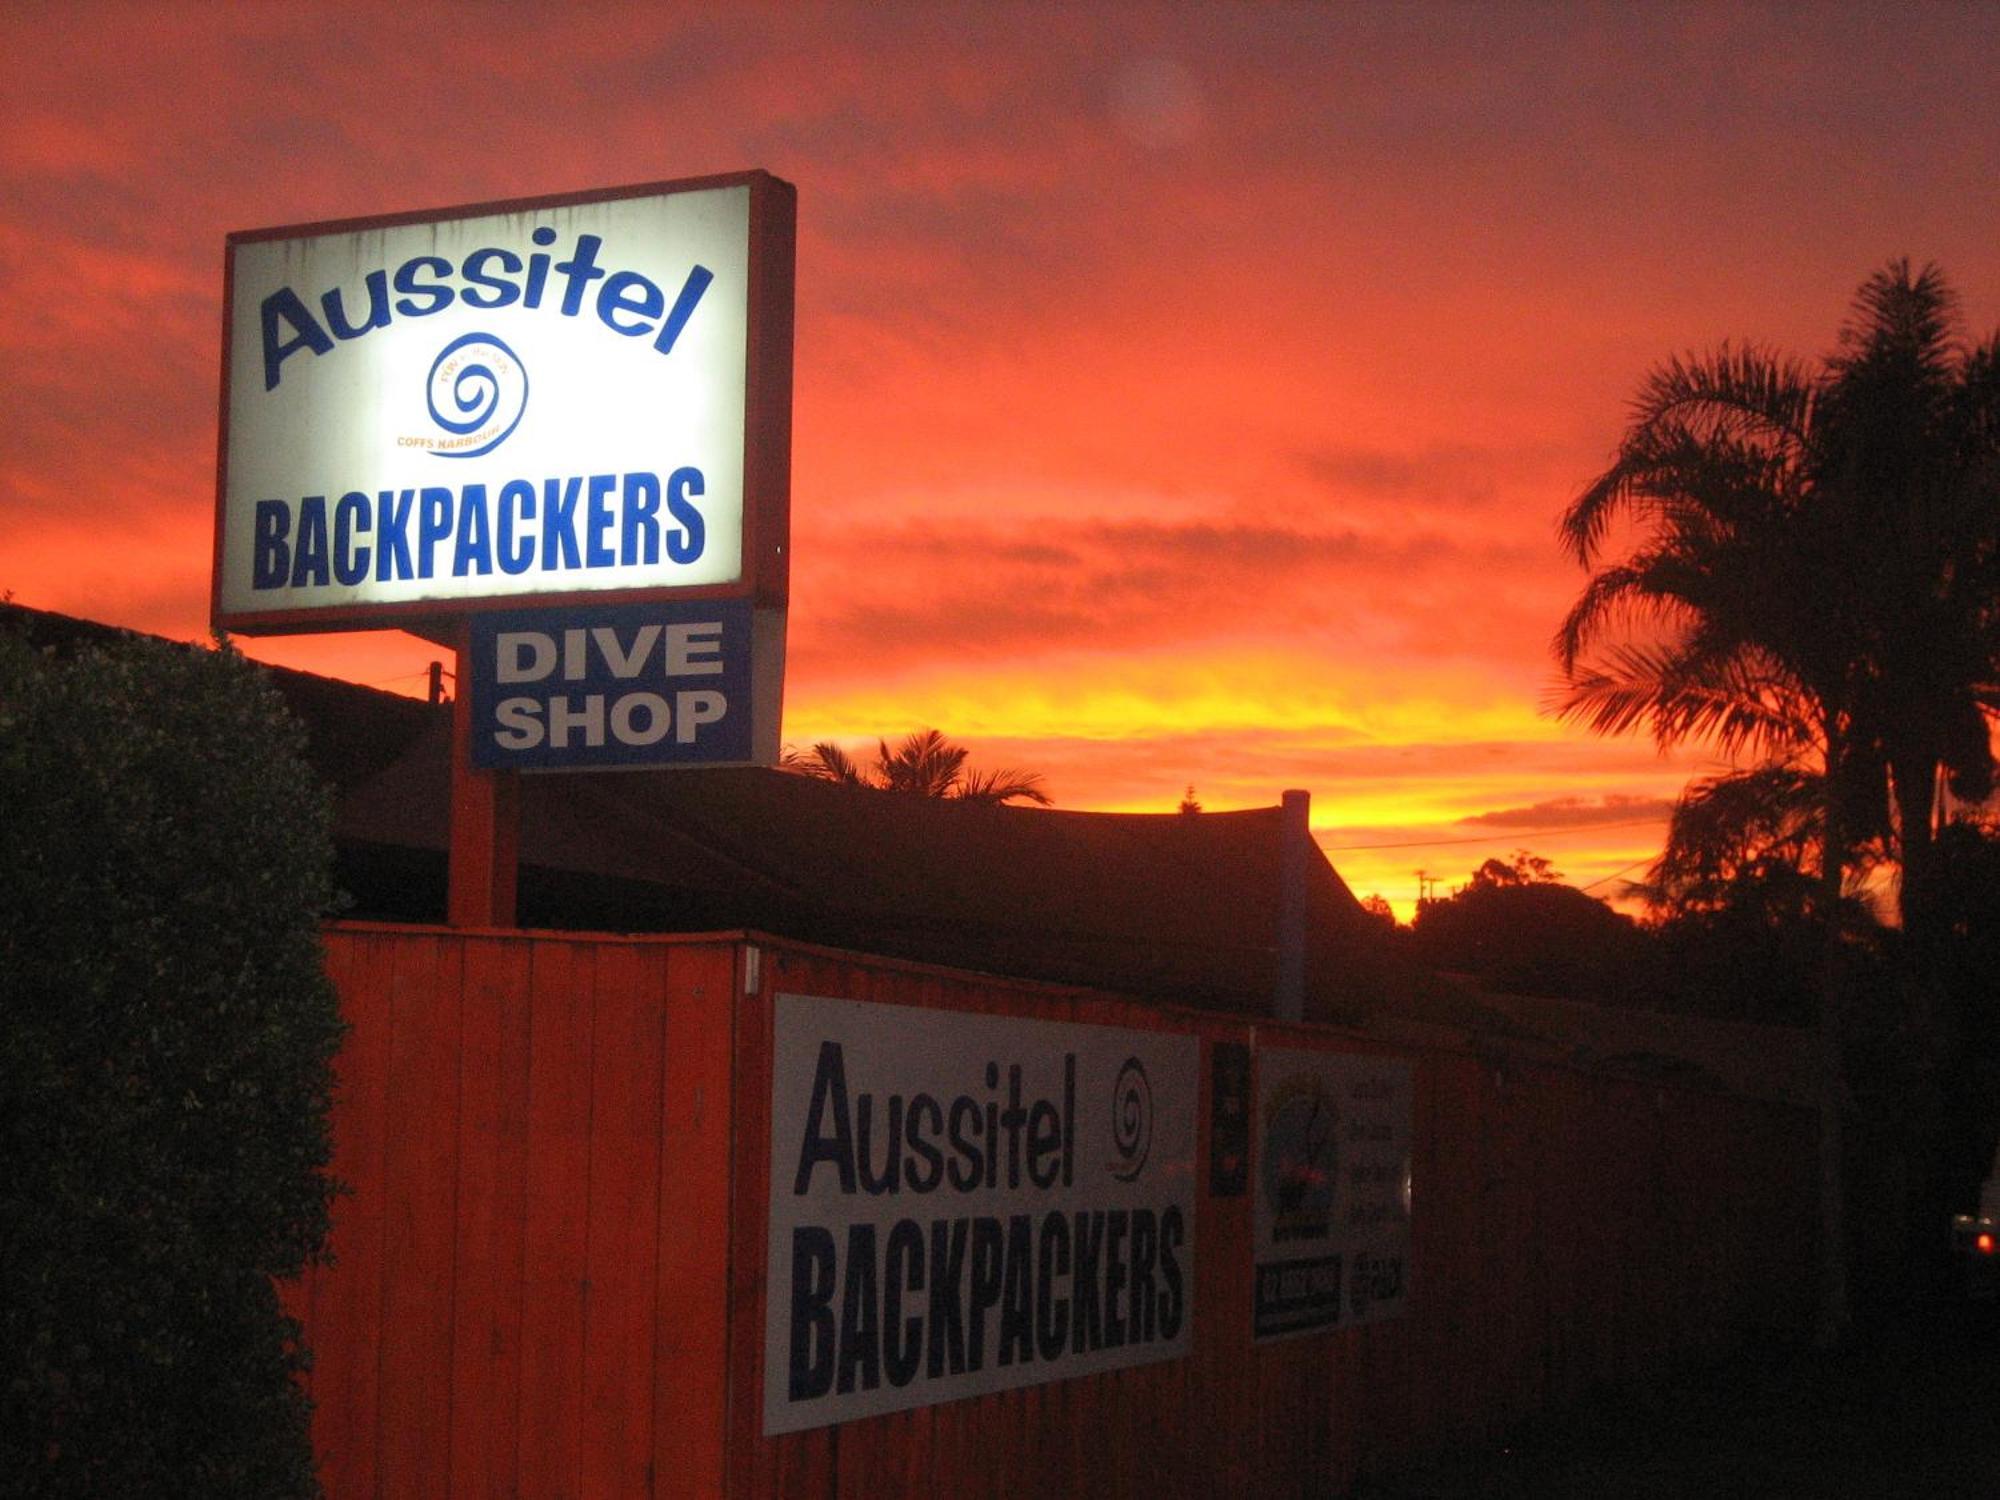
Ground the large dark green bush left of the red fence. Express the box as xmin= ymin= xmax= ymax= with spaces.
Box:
xmin=0 ymin=634 xmax=340 ymax=1500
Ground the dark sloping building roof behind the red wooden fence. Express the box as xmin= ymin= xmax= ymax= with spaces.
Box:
xmin=10 ymin=606 xmax=1392 ymax=1020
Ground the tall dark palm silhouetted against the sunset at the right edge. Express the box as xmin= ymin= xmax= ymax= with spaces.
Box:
xmin=1554 ymin=260 xmax=2000 ymax=1340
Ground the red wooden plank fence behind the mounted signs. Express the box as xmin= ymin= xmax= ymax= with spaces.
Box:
xmin=292 ymin=924 xmax=1814 ymax=1500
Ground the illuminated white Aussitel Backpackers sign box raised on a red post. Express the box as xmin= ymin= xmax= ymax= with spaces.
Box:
xmin=214 ymin=172 xmax=794 ymax=632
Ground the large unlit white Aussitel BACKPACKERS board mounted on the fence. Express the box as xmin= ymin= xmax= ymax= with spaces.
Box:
xmin=764 ymin=996 xmax=1200 ymax=1434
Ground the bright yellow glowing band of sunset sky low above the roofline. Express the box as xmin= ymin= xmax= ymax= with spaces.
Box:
xmin=786 ymin=650 xmax=1686 ymax=922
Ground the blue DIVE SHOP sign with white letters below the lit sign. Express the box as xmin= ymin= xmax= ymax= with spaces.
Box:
xmin=472 ymin=598 xmax=776 ymax=770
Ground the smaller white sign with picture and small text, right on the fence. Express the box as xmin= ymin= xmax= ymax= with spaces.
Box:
xmin=1252 ymin=1050 xmax=1412 ymax=1340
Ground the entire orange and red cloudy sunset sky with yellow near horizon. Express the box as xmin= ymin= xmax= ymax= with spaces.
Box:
xmin=0 ymin=4 xmax=2000 ymax=916
